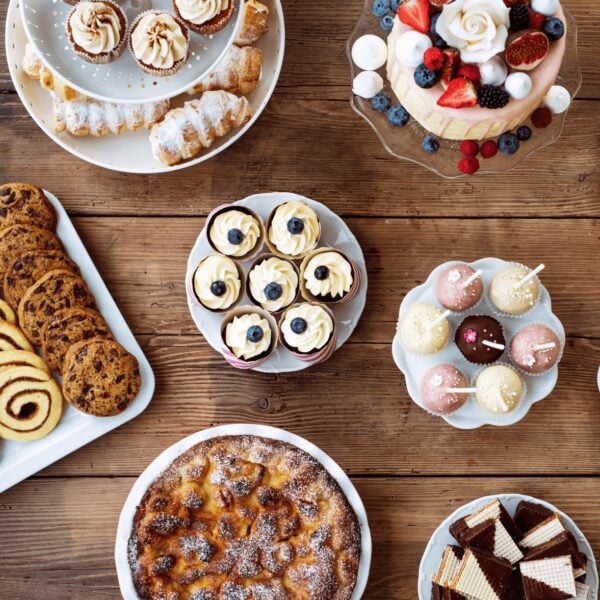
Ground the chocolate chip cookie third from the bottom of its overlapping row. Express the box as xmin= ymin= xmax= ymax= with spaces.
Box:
xmin=18 ymin=269 xmax=96 ymax=345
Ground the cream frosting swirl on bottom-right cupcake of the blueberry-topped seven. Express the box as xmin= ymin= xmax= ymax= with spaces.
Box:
xmin=281 ymin=303 xmax=334 ymax=354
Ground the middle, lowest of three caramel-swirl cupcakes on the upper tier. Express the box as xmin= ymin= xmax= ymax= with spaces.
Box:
xmin=129 ymin=10 xmax=190 ymax=77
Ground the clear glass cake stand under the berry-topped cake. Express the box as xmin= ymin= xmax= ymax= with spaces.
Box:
xmin=346 ymin=0 xmax=581 ymax=179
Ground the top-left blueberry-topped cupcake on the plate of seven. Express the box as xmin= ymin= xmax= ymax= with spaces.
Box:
xmin=207 ymin=204 xmax=265 ymax=260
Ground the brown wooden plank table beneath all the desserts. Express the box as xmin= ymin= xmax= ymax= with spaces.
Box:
xmin=0 ymin=0 xmax=600 ymax=600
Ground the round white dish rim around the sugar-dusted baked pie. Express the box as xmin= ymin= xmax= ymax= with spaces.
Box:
xmin=115 ymin=424 xmax=373 ymax=600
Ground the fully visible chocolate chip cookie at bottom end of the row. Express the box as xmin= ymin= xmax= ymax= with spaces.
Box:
xmin=63 ymin=338 xmax=141 ymax=417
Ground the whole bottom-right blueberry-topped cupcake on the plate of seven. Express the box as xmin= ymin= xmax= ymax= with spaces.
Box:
xmin=279 ymin=302 xmax=336 ymax=363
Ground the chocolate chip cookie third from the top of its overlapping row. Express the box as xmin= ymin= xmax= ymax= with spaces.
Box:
xmin=4 ymin=250 xmax=79 ymax=308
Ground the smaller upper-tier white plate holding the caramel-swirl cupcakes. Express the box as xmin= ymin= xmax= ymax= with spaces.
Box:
xmin=20 ymin=0 xmax=243 ymax=102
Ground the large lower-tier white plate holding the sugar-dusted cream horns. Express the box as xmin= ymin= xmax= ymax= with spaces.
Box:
xmin=5 ymin=0 xmax=285 ymax=174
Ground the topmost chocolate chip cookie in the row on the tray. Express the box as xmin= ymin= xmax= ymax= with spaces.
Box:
xmin=0 ymin=183 xmax=56 ymax=230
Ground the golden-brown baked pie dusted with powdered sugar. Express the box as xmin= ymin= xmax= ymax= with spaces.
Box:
xmin=129 ymin=435 xmax=360 ymax=600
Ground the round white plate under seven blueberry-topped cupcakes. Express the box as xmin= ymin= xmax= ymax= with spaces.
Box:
xmin=186 ymin=192 xmax=368 ymax=373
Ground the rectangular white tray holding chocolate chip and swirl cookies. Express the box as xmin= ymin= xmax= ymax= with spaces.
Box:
xmin=0 ymin=192 xmax=154 ymax=492
